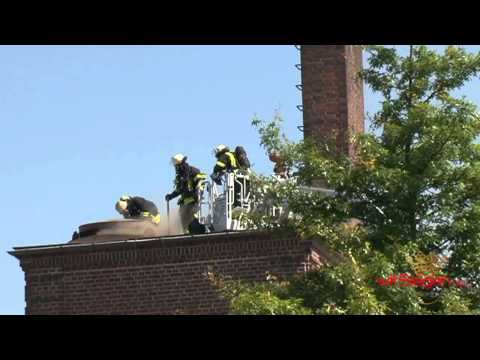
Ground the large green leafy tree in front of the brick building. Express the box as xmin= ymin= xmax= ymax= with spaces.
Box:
xmin=212 ymin=46 xmax=480 ymax=314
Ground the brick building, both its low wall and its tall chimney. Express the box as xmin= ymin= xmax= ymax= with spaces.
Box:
xmin=10 ymin=45 xmax=363 ymax=314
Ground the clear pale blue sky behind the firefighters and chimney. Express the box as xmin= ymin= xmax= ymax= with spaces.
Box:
xmin=0 ymin=45 xmax=480 ymax=314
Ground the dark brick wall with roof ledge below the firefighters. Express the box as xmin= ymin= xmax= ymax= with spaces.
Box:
xmin=11 ymin=233 xmax=329 ymax=314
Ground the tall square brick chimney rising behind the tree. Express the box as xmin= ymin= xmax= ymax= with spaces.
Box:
xmin=300 ymin=45 xmax=364 ymax=157
